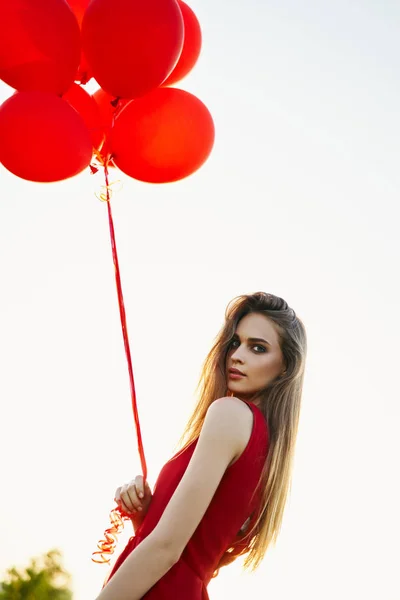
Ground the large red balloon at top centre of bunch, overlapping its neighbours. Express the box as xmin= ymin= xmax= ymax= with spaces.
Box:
xmin=82 ymin=0 xmax=183 ymax=98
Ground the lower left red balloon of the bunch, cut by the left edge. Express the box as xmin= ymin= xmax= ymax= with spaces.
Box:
xmin=0 ymin=92 xmax=92 ymax=182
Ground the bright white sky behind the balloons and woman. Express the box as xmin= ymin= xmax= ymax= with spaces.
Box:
xmin=0 ymin=0 xmax=400 ymax=600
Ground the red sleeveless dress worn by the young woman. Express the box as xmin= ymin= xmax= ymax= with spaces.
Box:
xmin=108 ymin=401 xmax=269 ymax=600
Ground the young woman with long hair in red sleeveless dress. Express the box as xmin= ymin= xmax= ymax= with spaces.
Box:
xmin=97 ymin=292 xmax=307 ymax=600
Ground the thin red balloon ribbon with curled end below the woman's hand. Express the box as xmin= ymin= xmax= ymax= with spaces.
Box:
xmin=92 ymin=160 xmax=147 ymax=563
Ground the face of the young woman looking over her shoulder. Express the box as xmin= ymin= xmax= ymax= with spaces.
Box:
xmin=226 ymin=313 xmax=284 ymax=399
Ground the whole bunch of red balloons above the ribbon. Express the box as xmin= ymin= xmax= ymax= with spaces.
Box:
xmin=0 ymin=0 xmax=214 ymax=183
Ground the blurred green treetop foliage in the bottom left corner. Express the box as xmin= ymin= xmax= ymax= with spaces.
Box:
xmin=0 ymin=549 xmax=72 ymax=600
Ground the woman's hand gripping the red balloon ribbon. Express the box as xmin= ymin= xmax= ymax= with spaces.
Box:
xmin=114 ymin=475 xmax=153 ymax=531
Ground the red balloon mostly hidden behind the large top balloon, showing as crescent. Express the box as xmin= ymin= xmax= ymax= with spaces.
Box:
xmin=163 ymin=0 xmax=202 ymax=85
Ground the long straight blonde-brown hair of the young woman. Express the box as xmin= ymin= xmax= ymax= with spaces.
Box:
xmin=173 ymin=292 xmax=307 ymax=577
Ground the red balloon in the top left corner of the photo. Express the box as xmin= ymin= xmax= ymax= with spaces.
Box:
xmin=0 ymin=0 xmax=80 ymax=94
